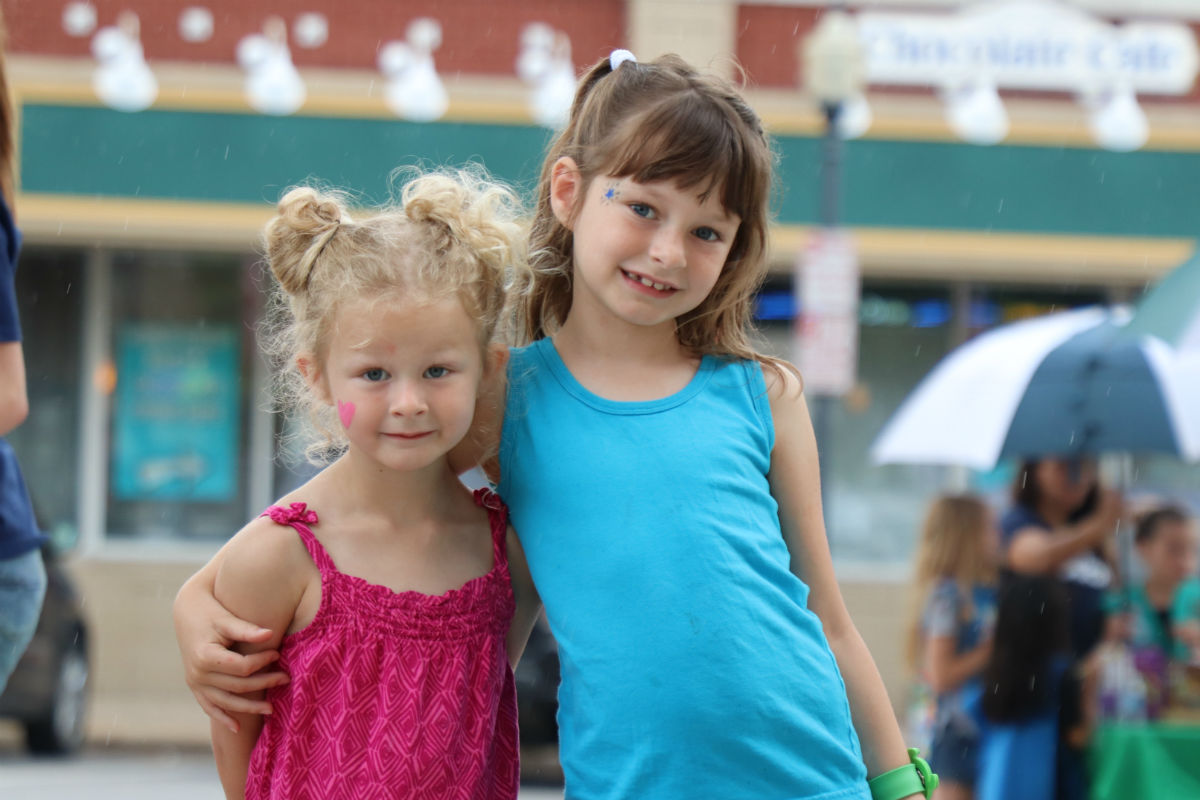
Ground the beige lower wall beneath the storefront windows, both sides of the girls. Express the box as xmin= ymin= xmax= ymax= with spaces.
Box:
xmin=70 ymin=560 xmax=906 ymax=745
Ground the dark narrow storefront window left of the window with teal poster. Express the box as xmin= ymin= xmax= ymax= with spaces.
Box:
xmin=7 ymin=247 xmax=85 ymax=548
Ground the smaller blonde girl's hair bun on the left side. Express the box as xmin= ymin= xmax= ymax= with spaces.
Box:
xmin=265 ymin=186 xmax=350 ymax=295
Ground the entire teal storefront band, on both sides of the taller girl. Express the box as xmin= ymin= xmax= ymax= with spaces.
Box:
xmin=22 ymin=104 xmax=1200 ymax=236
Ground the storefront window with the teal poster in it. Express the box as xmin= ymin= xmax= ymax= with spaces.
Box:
xmin=107 ymin=253 xmax=258 ymax=539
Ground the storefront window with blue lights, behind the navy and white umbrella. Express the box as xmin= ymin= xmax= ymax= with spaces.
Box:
xmin=757 ymin=281 xmax=1152 ymax=564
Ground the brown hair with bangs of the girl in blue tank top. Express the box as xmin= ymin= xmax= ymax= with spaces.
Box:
xmin=522 ymin=55 xmax=779 ymax=366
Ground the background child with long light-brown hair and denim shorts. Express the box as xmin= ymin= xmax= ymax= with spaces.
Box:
xmin=908 ymin=495 xmax=998 ymax=800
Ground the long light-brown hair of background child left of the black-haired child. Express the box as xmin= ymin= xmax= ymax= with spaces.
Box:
xmin=907 ymin=494 xmax=996 ymax=670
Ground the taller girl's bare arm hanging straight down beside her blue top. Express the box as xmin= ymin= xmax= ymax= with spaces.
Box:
xmin=763 ymin=368 xmax=918 ymax=796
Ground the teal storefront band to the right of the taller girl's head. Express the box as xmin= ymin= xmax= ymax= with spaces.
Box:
xmin=778 ymin=137 xmax=1200 ymax=236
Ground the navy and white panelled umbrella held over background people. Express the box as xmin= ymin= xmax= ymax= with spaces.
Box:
xmin=871 ymin=307 xmax=1200 ymax=470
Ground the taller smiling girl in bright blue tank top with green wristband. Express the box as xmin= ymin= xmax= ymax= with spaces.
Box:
xmin=176 ymin=50 xmax=936 ymax=800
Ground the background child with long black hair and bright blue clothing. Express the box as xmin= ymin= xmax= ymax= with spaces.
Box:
xmin=976 ymin=575 xmax=1092 ymax=800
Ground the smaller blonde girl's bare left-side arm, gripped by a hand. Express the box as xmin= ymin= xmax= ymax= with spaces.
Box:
xmin=211 ymin=517 xmax=316 ymax=800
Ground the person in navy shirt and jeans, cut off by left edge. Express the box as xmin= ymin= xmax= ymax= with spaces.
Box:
xmin=0 ymin=6 xmax=46 ymax=692
